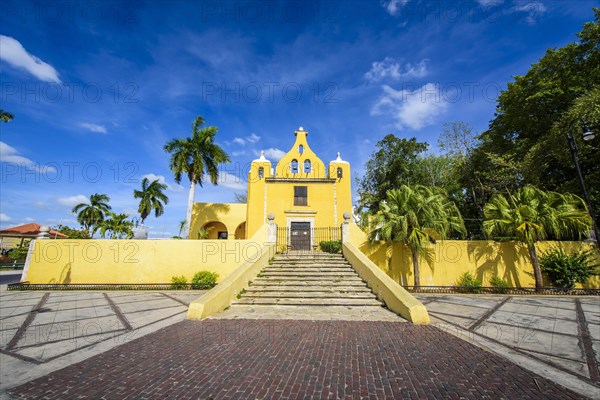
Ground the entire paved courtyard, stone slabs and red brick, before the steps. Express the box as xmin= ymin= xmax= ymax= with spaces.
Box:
xmin=0 ymin=291 xmax=600 ymax=399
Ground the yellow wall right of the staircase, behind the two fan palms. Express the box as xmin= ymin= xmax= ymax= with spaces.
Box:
xmin=350 ymin=224 xmax=600 ymax=288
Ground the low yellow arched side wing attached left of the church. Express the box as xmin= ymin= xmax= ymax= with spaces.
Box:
xmin=190 ymin=203 xmax=248 ymax=239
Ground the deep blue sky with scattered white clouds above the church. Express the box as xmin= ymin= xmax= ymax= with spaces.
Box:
xmin=0 ymin=0 xmax=600 ymax=237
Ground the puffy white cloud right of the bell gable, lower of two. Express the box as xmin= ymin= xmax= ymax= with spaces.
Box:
xmin=371 ymin=83 xmax=448 ymax=129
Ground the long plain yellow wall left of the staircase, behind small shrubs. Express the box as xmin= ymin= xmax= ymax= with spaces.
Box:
xmin=22 ymin=225 xmax=267 ymax=284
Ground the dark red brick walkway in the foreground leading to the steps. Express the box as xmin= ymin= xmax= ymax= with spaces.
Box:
xmin=9 ymin=320 xmax=583 ymax=399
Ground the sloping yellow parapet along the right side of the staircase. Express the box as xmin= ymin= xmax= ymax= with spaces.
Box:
xmin=343 ymin=242 xmax=429 ymax=325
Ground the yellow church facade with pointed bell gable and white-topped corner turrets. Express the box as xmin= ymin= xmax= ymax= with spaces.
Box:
xmin=247 ymin=130 xmax=352 ymax=238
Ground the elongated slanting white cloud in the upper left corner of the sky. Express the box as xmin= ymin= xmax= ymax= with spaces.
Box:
xmin=0 ymin=35 xmax=61 ymax=83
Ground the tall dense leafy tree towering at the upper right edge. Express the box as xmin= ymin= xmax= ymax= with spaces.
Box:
xmin=473 ymin=8 xmax=600 ymax=214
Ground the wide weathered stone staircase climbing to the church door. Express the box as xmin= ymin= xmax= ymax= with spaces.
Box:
xmin=233 ymin=253 xmax=383 ymax=310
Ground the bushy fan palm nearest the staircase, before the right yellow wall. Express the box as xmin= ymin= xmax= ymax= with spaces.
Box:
xmin=370 ymin=185 xmax=466 ymax=286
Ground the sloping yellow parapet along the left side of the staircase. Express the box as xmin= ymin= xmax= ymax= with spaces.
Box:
xmin=186 ymin=225 xmax=276 ymax=320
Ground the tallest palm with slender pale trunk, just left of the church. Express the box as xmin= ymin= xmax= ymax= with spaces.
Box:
xmin=164 ymin=116 xmax=229 ymax=239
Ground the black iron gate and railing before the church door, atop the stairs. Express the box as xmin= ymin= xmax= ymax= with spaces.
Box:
xmin=277 ymin=222 xmax=342 ymax=253
